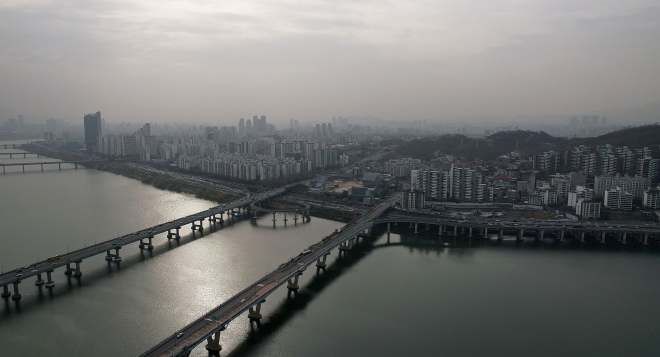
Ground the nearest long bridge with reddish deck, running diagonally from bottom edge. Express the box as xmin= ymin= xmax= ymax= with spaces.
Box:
xmin=141 ymin=200 xmax=394 ymax=357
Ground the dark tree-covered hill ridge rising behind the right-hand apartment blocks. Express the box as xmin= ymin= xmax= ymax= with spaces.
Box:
xmin=396 ymin=124 xmax=660 ymax=160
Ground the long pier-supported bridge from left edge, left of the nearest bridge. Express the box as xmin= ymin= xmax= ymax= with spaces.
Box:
xmin=0 ymin=186 xmax=288 ymax=300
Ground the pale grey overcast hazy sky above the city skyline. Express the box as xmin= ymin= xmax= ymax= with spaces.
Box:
xmin=0 ymin=0 xmax=660 ymax=123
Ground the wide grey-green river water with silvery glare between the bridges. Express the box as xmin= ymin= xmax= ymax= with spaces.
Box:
xmin=0 ymin=143 xmax=660 ymax=357
